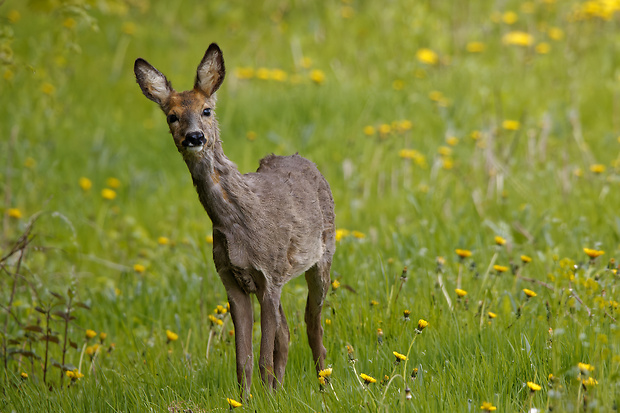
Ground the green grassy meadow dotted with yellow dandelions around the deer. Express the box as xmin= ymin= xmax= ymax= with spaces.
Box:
xmin=0 ymin=0 xmax=620 ymax=412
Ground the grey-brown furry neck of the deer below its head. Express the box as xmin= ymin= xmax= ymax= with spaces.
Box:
xmin=184 ymin=139 xmax=258 ymax=229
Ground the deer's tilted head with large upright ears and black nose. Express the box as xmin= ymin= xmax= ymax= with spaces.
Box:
xmin=134 ymin=43 xmax=226 ymax=157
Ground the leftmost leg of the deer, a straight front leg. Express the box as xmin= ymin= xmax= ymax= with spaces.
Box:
xmin=220 ymin=273 xmax=254 ymax=399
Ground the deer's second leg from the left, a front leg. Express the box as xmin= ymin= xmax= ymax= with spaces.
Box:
xmin=257 ymin=288 xmax=280 ymax=389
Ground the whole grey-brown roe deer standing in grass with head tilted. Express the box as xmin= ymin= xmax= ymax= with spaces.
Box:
xmin=134 ymin=43 xmax=335 ymax=396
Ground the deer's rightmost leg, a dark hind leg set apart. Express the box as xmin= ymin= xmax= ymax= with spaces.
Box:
xmin=305 ymin=260 xmax=331 ymax=373
